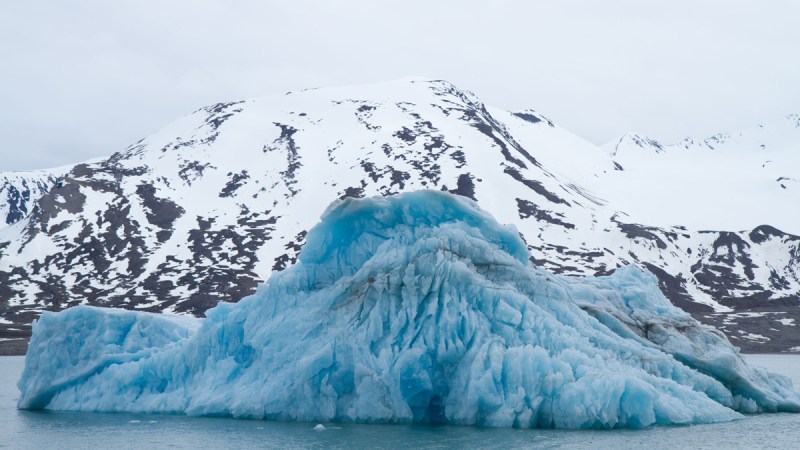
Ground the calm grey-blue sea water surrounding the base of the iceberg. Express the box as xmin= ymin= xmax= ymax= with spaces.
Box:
xmin=0 ymin=355 xmax=800 ymax=450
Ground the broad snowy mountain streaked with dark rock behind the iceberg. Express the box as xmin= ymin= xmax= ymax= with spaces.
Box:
xmin=0 ymin=80 xmax=800 ymax=351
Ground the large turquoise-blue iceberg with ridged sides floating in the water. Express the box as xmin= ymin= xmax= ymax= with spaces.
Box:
xmin=18 ymin=191 xmax=800 ymax=428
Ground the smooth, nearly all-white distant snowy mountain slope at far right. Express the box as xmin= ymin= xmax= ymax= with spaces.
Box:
xmin=600 ymin=114 xmax=800 ymax=234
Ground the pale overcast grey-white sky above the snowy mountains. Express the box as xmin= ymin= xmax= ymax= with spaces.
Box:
xmin=0 ymin=0 xmax=800 ymax=171
